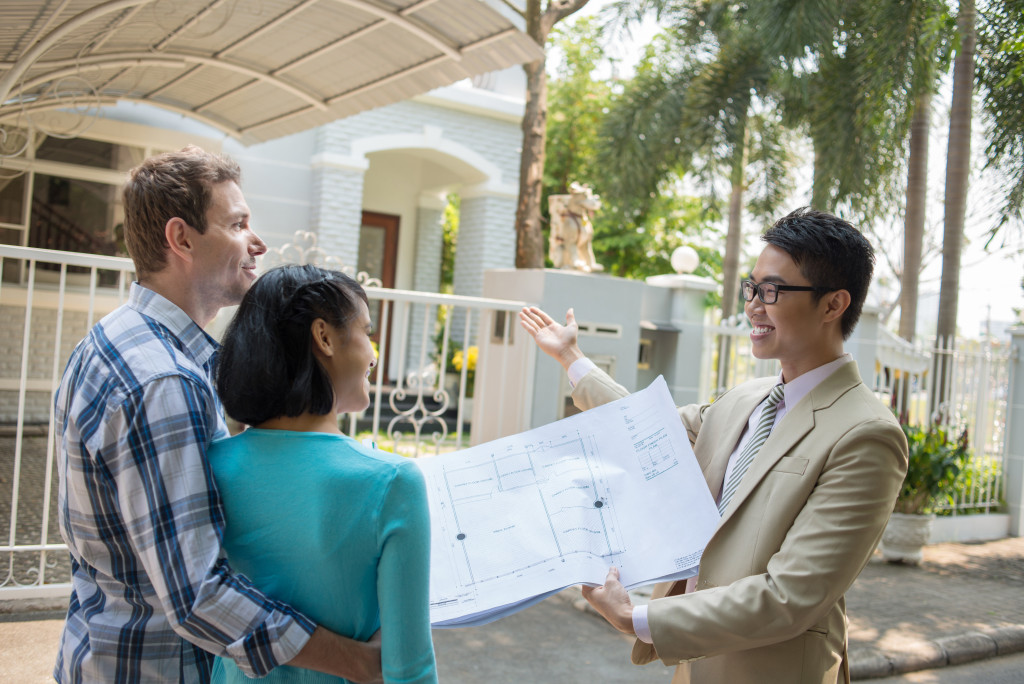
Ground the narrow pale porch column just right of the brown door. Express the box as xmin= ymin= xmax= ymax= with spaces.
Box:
xmin=406 ymin=194 xmax=447 ymax=370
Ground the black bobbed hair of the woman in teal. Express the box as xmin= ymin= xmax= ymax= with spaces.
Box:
xmin=214 ymin=265 xmax=367 ymax=425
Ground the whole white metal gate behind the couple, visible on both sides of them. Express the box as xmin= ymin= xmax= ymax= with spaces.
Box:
xmin=0 ymin=246 xmax=525 ymax=600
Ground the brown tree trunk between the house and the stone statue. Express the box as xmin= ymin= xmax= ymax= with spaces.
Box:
xmin=515 ymin=59 xmax=548 ymax=268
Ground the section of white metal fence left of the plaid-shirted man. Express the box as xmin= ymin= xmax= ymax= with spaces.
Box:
xmin=0 ymin=245 xmax=133 ymax=599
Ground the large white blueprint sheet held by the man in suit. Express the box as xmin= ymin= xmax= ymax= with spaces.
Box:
xmin=417 ymin=378 xmax=719 ymax=627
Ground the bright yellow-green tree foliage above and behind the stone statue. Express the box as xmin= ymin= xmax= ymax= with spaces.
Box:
xmin=543 ymin=17 xmax=722 ymax=279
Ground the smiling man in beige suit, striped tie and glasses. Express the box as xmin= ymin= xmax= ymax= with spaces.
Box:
xmin=520 ymin=210 xmax=906 ymax=684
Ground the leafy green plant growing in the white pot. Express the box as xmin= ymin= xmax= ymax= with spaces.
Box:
xmin=894 ymin=423 xmax=969 ymax=513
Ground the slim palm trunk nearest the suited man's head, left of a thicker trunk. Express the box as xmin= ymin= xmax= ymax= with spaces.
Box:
xmin=899 ymin=89 xmax=932 ymax=342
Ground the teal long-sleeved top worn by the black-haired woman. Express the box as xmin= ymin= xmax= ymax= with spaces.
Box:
xmin=209 ymin=428 xmax=437 ymax=684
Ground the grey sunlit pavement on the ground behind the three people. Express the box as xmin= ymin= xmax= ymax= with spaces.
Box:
xmin=0 ymin=538 xmax=1024 ymax=684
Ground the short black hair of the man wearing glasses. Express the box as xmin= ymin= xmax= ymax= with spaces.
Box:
xmin=761 ymin=207 xmax=874 ymax=340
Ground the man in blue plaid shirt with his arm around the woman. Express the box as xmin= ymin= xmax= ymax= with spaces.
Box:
xmin=53 ymin=146 xmax=380 ymax=682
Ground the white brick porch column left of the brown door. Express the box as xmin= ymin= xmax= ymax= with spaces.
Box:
xmin=310 ymin=152 xmax=370 ymax=269
